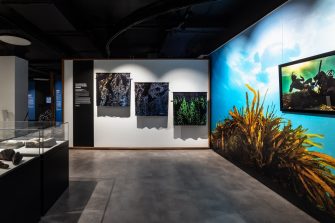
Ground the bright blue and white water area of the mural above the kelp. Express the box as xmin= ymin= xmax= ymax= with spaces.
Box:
xmin=211 ymin=0 xmax=335 ymax=157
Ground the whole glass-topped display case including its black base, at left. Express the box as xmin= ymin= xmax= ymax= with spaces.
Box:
xmin=0 ymin=122 xmax=69 ymax=222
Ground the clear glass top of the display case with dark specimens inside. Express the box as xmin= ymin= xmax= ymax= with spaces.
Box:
xmin=0 ymin=122 xmax=69 ymax=175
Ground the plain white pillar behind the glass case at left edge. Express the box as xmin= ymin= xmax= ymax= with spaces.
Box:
xmin=0 ymin=56 xmax=28 ymax=121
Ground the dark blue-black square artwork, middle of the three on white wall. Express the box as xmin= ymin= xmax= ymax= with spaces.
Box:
xmin=135 ymin=82 xmax=169 ymax=116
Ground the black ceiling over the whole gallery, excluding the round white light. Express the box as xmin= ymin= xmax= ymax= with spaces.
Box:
xmin=0 ymin=0 xmax=286 ymax=74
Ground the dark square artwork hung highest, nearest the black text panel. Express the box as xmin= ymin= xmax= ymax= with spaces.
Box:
xmin=96 ymin=73 xmax=130 ymax=107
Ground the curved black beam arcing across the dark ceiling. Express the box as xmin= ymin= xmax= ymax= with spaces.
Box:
xmin=106 ymin=0 xmax=217 ymax=57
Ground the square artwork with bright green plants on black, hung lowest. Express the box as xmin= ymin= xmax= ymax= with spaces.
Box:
xmin=173 ymin=92 xmax=207 ymax=125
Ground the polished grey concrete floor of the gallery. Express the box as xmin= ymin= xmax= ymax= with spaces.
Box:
xmin=41 ymin=150 xmax=317 ymax=223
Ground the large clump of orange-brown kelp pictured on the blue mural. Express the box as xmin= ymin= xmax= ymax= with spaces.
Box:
xmin=211 ymin=86 xmax=335 ymax=216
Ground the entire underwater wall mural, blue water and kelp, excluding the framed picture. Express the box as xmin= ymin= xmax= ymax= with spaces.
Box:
xmin=211 ymin=0 xmax=335 ymax=217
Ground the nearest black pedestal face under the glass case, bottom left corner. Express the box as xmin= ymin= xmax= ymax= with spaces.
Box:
xmin=0 ymin=157 xmax=41 ymax=223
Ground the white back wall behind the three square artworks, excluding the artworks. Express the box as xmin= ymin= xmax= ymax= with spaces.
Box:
xmin=64 ymin=60 xmax=209 ymax=148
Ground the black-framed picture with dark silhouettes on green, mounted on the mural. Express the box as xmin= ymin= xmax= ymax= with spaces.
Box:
xmin=279 ymin=52 xmax=335 ymax=113
